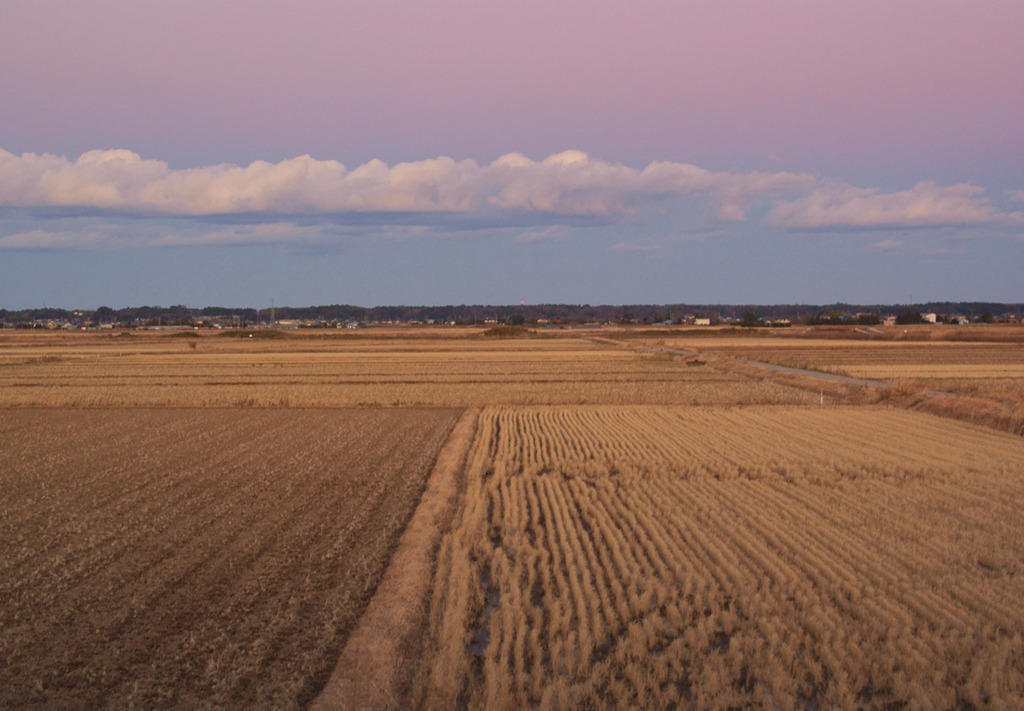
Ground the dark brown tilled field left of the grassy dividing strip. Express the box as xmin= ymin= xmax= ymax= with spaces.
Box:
xmin=0 ymin=408 xmax=458 ymax=709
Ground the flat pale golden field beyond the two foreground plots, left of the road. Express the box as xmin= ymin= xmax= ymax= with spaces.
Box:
xmin=0 ymin=329 xmax=811 ymax=407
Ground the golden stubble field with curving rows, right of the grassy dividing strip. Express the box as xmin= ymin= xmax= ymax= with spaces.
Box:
xmin=411 ymin=407 xmax=1024 ymax=709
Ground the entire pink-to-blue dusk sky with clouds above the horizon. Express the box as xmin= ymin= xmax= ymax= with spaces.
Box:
xmin=0 ymin=0 xmax=1024 ymax=309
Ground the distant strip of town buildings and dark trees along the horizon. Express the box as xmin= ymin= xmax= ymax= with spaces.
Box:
xmin=0 ymin=301 xmax=1024 ymax=330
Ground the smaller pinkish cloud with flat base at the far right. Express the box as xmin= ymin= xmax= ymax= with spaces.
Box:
xmin=765 ymin=180 xmax=1024 ymax=229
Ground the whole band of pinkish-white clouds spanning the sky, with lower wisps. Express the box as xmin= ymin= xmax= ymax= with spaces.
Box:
xmin=0 ymin=150 xmax=1024 ymax=249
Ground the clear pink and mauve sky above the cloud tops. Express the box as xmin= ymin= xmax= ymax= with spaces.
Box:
xmin=0 ymin=0 xmax=1024 ymax=179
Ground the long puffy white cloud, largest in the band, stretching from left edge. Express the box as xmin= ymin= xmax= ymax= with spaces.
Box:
xmin=0 ymin=146 xmax=813 ymax=220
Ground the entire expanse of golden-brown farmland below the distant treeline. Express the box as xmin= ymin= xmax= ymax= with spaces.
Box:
xmin=0 ymin=329 xmax=1024 ymax=709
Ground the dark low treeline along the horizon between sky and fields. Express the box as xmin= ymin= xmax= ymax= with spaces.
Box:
xmin=0 ymin=301 xmax=1024 ymax=328
